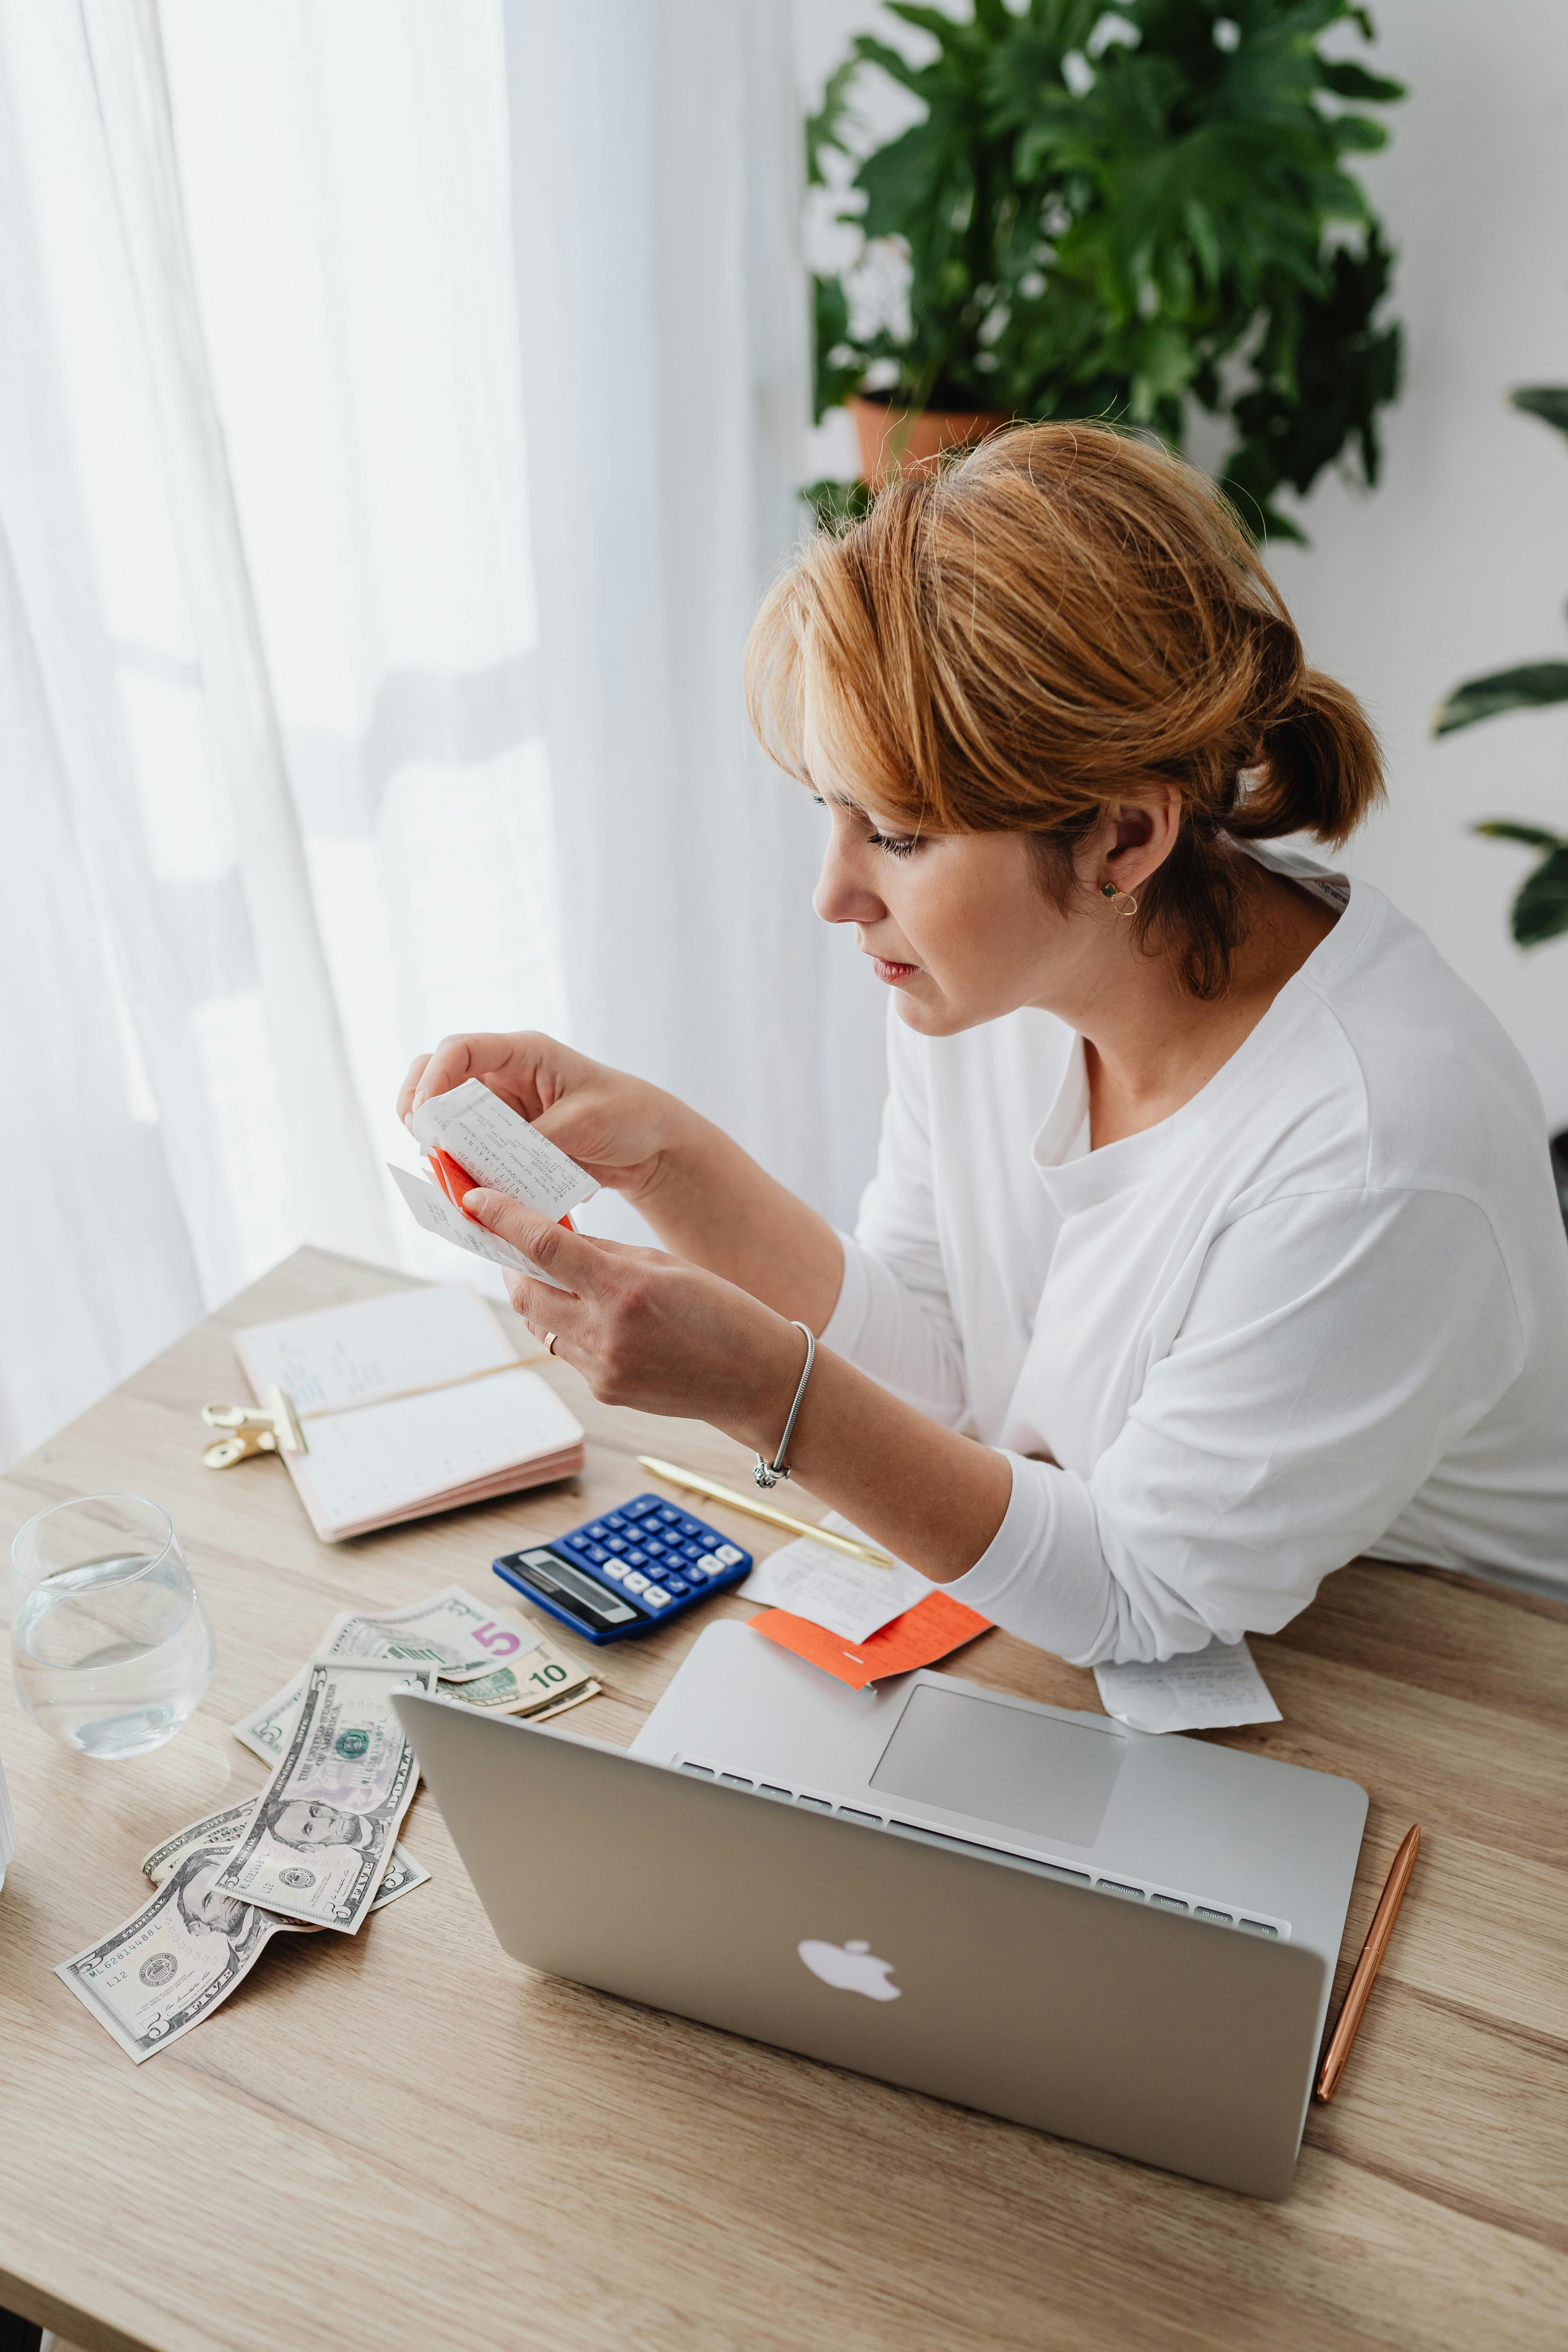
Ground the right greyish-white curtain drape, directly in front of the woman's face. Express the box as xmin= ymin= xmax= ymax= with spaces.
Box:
xmin=505 ymin=0 xmax=884 ymax=1218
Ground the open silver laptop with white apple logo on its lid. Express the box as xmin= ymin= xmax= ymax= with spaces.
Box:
xmin=395 ymin=1623 xmax=1366 ymax=2197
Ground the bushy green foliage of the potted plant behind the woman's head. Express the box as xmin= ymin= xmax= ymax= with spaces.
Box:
xmin=806 ymin=0 xmax=1404 ymax=539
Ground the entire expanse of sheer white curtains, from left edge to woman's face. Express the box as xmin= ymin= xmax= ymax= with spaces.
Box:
xmin=0 ymin=0 xmax=882 ymax=1458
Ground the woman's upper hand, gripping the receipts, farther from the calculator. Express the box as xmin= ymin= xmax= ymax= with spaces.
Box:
xmin=397 ymin=1030 xmax=691 ymax=1199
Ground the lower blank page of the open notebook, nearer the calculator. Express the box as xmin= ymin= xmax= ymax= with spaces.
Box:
xmin=289 ymin=1366 xmax=583 ymax=1529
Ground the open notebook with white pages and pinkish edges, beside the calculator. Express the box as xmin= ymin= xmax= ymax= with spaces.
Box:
xmin=235 ymin=1282 xmax=583 ymax=1543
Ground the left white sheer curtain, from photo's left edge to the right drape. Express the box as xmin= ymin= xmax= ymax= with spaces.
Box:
xmin=0 ymin=0 xmax=564 ymax=1458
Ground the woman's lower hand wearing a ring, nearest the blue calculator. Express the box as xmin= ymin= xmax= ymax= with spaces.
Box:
xmin=463 ymin=1190 xmax=804 ymax=1449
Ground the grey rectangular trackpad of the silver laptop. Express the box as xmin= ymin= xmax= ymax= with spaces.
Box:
xmin=870 ymin=1682 xmax=1126 ymax=1846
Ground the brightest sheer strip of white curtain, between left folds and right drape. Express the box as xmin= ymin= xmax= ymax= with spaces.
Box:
xmin=160 ymin=0 xmax=567 ymax=1275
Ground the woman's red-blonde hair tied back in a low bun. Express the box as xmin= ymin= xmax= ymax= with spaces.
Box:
xmin=745 ymin=424 xmax=1382 ymax=997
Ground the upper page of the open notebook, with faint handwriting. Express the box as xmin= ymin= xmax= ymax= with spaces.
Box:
xmin=235 ymin=1282 xmax=517 ymax=1414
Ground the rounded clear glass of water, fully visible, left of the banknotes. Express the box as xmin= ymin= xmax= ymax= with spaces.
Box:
xmin=12 ymin=1493 xmax=216 ymax=1757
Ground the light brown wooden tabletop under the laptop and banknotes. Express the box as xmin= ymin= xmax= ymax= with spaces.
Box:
xmin=0 ymin=1251 xmax=1568 ymax=2352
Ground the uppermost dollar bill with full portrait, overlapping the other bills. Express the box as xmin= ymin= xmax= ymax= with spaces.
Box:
xmin=214 ymin=1658 xmax=435 ymax=1936
